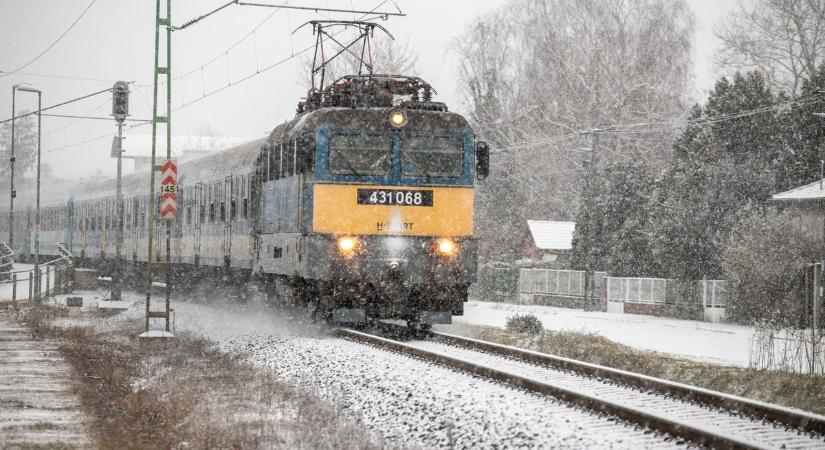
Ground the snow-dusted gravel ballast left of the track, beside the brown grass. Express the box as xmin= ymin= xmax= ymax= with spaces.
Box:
xmin=56 ymin=292 xmax=676 ymax=448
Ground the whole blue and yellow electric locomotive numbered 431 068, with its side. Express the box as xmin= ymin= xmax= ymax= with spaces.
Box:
xmin=256 ymin=75 xmax=489 ymax=326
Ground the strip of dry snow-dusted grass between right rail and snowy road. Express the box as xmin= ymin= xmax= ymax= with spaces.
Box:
xmin=453 ymin=326 xmax=825 ymax=414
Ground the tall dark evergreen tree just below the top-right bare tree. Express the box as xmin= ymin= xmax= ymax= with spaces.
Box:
xmin=654 ymin=72 xmax=783 ymax=279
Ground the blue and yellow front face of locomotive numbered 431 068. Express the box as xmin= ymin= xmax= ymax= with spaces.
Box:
xmin=308 ymin=103 xmax=487 ymax=325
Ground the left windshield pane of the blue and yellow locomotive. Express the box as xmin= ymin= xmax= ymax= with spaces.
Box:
xmin=329 ymin=135 xmax=392 ymax=175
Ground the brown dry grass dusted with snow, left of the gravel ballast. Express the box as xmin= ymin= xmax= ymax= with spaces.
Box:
xmin=33 ymin=300 xmax=388 ymax=449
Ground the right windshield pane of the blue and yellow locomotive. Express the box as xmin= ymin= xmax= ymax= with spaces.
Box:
xmin=401 ymin=136 xmax=464 ymax=178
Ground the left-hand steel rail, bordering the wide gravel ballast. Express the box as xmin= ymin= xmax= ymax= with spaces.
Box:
xmin=335 ymin=328 xmax=767 ymax=449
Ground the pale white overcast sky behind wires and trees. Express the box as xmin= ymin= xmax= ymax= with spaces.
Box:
xmin=0 ymin=0 xmax=736 ymax=178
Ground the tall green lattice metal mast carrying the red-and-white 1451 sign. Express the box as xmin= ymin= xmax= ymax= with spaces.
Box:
xmin=145 ymin=0 xmax=172 ymax=332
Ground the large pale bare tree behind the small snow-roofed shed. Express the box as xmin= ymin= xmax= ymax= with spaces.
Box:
xmin=455 ymin=0 xmax=694 ymax=260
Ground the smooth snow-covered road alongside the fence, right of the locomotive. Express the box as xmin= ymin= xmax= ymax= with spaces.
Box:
xmin=454 ymin=301 xmax=754 ymax=367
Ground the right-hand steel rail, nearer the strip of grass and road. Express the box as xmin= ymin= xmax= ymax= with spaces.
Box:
xmin=431 ymin=332 xmax=825 ymax=435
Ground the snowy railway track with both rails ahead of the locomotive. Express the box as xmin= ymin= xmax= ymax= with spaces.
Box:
xmin=336 ymin=326 xmax=825 ymax=449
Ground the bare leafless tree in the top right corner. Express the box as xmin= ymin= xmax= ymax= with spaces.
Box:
xmin=714 ymin=0 xmax=825 ymax=94
